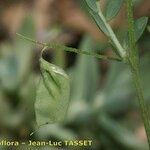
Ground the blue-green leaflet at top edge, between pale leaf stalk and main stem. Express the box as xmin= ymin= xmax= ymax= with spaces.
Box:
xmin=104 ymin=0 xmax=124 ymax=20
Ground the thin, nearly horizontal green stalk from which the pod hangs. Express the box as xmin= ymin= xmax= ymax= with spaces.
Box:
xmin=17 ymin=33 xmax=122 ymax=61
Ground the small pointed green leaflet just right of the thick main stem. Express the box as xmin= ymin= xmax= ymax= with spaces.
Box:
xmin=135 ymin=17 xmax=148 ymax=41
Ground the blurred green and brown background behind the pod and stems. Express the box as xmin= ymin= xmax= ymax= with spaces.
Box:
xmin=0 ymin=0 xmax=150 ymax=150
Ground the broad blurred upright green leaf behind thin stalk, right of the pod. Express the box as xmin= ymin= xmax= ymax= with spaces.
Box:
xmin=71 ymin=36 xmax=99 ymax=100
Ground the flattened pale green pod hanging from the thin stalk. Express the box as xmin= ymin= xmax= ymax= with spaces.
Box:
xmin=35 ymin=58 xmax=70 ymax=126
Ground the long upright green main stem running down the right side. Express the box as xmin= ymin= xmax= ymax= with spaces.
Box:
xmin=127 ymin=0 xmax=150 ymax=147
